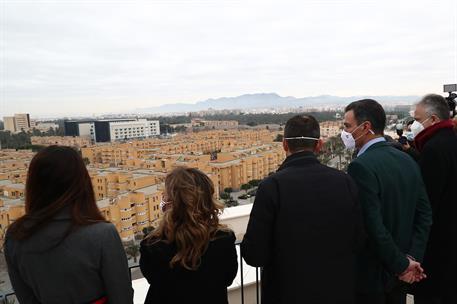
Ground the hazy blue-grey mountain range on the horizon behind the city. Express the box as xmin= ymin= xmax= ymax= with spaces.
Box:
xmin=136 ymin=93 xmax=419 ymax=114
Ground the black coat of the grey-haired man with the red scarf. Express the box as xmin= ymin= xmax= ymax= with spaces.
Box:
xmin=415 ymin=128 xmax=457 ymax=299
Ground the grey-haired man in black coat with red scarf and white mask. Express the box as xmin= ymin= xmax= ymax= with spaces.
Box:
xmin=411 ymin=94 xmax=457 ymax=304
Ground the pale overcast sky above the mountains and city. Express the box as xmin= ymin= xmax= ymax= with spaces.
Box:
xmin=0 ymin=0 xmax=457 ymax=119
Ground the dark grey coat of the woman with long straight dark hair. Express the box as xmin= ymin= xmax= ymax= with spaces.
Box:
xmin=5 ymin=212 xmax=133 ymax=304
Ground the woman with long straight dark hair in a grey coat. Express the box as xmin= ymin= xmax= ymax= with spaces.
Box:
xmin=5 ymin=146 xmax=133 ymax=304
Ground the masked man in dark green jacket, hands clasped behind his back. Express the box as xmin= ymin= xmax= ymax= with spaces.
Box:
xmin=341 ymin=99 xmax=432 ymax=304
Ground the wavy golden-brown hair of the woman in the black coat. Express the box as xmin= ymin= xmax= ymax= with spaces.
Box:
xmin=146 ymin=167 xmax=228 ymax=270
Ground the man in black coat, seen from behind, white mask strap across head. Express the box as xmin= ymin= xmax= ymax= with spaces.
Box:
xmin=241 ymin=116 xmax=364 ymax=304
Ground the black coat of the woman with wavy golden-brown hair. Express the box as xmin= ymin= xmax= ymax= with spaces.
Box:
xmin=140 ymin=231 xmax=238 ymax=304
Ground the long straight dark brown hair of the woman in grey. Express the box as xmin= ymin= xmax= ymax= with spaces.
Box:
xmin=8 ymin=146 xmax=105 ymax=240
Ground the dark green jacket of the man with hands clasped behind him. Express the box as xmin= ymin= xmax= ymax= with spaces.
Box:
xmin=348 ymin=142 xmax=432 ymax=294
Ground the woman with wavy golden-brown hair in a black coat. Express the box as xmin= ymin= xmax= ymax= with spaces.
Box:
xmin=140 ymin=168 xmax=238 ymax=304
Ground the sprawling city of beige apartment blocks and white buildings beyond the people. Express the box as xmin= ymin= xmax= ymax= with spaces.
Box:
xmin=0 ymin=106 xmax=409 ymax=291
